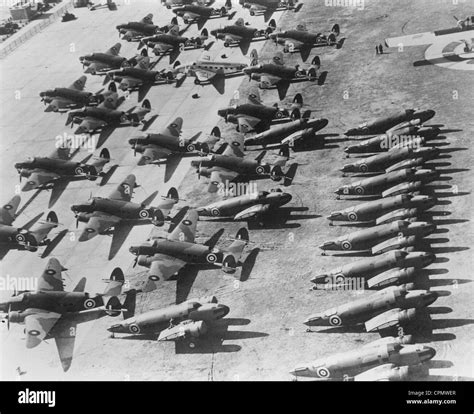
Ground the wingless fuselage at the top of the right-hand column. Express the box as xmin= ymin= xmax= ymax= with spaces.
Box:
xmin=344 ymin=109 xmax=436 ymax=136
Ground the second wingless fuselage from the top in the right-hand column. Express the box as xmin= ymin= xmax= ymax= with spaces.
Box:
xmin=344 ymin=122 xmax=441 ymax=154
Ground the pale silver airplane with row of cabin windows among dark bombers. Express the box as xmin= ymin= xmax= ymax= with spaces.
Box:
xmin=173 ymin=55 xmax=248 ymax=95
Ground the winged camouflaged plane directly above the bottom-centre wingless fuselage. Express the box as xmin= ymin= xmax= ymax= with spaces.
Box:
xmin=129 ymin=209 xmax=249 ymax=292
